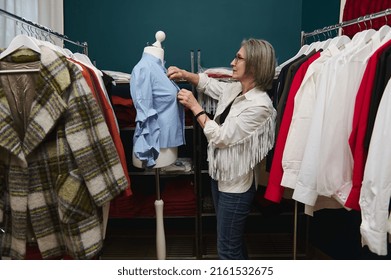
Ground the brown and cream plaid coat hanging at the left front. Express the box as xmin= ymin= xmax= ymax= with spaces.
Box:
xmin=0 ymin=46 xmax=127 ymax=259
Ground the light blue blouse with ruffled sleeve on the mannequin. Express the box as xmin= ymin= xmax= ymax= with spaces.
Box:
xmin=130 ymin=53 xmax=185 ymax=168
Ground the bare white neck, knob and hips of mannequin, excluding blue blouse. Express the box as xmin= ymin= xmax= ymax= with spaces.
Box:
xmin=132 ymin=31 xmax=178 ymax=168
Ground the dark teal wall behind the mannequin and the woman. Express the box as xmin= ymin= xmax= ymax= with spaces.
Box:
xmin=64 ymin=0 xmax=339 ymax=73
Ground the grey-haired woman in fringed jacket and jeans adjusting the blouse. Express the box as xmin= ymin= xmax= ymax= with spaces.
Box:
xmin=167 ymin=39 xmax=276 ymax=259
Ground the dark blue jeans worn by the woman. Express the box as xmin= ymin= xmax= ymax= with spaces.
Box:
xmin=211 ymin=180 xmax=255 ymax=260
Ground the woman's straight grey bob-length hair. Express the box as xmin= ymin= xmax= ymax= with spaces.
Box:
xmin=241 ymin=38 xmax=276 ymax=91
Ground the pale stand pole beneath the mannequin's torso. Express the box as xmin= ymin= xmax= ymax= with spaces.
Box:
xmin=155 ymin=168 xmax=166 ymax=260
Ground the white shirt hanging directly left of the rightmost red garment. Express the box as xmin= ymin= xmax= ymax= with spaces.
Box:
xmin=317 ymin=30 xmax=380 ymax=205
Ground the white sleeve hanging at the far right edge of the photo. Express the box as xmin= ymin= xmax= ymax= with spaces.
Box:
xmin=360 ymin=77 xmax=391 ymax=255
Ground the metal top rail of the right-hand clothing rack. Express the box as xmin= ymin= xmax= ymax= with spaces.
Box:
xmin=301 ymin=8 xmax=391 ymax=45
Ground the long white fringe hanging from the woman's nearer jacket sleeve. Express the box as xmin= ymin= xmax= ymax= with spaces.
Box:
xmin=208 ymin=110 xmax=277 ymax=181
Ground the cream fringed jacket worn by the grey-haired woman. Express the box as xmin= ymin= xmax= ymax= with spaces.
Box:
xmin=197 ymin=74 xmax=276 ymax=193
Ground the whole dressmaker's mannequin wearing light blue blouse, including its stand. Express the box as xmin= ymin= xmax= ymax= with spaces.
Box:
xmin=131 ymin=31 xmax=185 ymax=260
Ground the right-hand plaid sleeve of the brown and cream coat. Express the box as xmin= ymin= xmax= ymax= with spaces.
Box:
xmin=65 ymin=65 xmax=127 ymax=206
